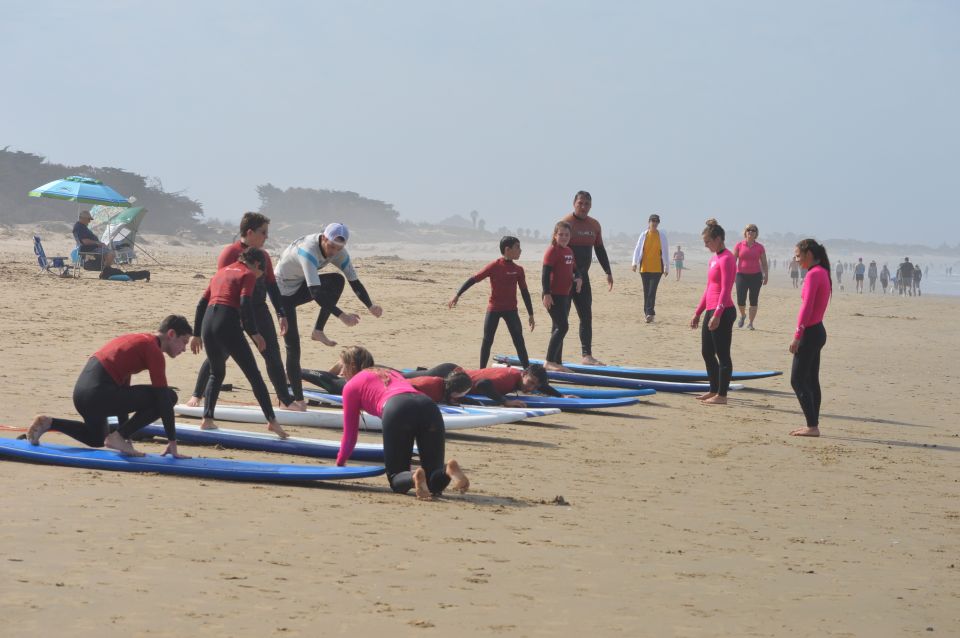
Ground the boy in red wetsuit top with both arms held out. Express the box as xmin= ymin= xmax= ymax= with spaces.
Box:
xmin=447 ymin=236 xmax=536 ymax=368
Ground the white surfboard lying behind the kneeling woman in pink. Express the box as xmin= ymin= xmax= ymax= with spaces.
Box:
xmin=173 ymin=404 xmax=560 ymax=432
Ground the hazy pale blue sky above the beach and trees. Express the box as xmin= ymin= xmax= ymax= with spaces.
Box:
xmin=0 ymin=0 xmax=960 ymax=246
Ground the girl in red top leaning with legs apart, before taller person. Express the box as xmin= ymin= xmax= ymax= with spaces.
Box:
xmin=190 ymin=246 xmax=287 ymax=439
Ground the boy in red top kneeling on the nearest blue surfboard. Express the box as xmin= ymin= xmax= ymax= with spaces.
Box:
xmin=27 ymin=315 xmax=193 ymax=459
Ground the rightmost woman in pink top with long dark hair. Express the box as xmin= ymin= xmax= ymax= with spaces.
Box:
xmin=789 ymin=239 xmax=833 ymax=436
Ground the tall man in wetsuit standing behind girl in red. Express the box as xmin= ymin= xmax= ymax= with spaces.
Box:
xmin=561 ymin=191 xmax=613 ymax=366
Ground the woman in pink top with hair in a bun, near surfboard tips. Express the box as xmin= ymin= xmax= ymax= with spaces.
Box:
xmin=690 ymin=219 xmax=737 ymax=405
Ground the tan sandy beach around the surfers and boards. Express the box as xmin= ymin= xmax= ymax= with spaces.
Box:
xmin=0 ymin=229 xmax=960 ymax=636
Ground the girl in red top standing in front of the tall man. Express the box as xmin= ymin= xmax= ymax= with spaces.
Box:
xmin=544 ymin=222 xmax=583 ymax=372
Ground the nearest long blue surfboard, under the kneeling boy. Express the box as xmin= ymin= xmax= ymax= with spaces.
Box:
xmin=0 ymin=438 xmax=385 ymax=483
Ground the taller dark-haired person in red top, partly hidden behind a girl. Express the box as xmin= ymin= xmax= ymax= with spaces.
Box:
xmin=187 ymin=212 xmax=307 ymax=411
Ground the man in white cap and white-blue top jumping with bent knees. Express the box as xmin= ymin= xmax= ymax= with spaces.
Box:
xmin=274 ymin=223 xmax=383 ymax=401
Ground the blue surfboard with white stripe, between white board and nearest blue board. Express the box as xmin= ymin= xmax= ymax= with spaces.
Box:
xmin=137 ymin=423 xmax=383 ymax=462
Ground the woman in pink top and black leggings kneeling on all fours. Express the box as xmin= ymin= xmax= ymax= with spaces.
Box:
xmin=337 ymin=346 xmax=470 ymax=500
